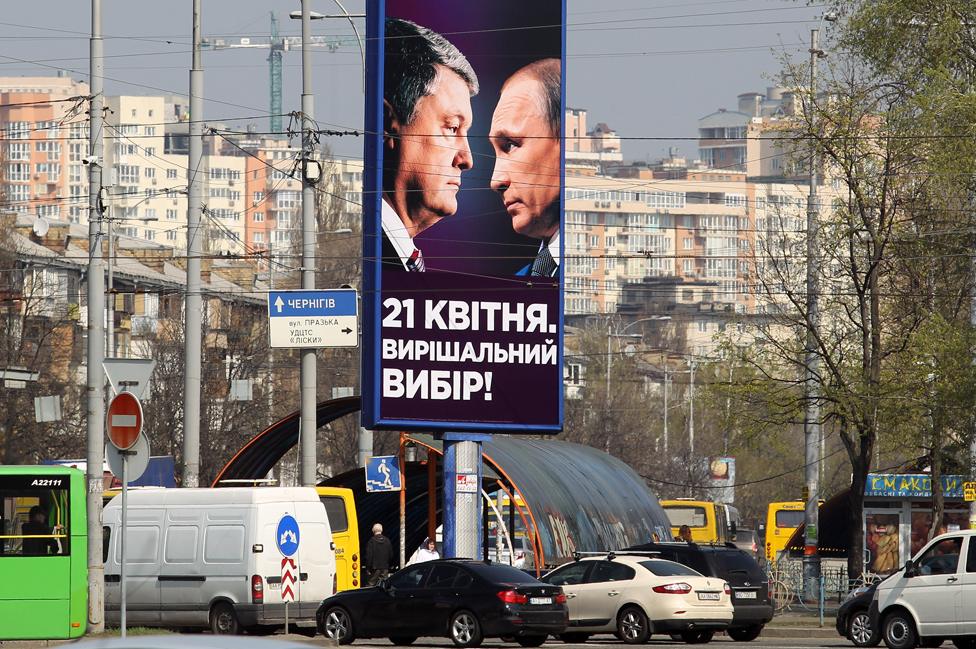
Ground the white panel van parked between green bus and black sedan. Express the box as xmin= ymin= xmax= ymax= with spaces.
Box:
xmin=103 ymin=487 xmax=336 ymax=634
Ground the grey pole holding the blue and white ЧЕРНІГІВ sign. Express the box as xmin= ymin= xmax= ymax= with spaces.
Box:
xmin=299 ymin=0 xmax=319 ymax=487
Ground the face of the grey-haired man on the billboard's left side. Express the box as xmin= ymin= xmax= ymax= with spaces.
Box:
xmin=387 ymin=65 xmax=473 ymax=235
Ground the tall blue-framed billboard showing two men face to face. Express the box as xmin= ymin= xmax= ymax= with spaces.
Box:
xmin=362 ymin=0 xmax=565 ymax=433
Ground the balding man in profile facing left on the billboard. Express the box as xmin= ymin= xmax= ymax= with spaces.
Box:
xmin=490 ymin=58 xmax=562 ymax=277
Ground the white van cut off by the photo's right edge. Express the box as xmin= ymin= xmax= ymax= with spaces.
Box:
xmin=870 ymin=530 xmax=976 ymax=649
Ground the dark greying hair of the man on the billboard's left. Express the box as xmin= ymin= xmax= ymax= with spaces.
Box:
xmin=383 ymin=18 xmax=479 ymax=124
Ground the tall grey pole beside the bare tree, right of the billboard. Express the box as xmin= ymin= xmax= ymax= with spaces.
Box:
xmin=803 ymin=28 xmax=824 ymax=601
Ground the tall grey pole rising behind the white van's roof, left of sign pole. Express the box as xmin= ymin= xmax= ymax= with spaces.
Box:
xmin=183 ymin=0 xmax=203 ymax=487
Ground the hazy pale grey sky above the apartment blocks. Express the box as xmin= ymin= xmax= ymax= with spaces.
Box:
xmin=0 ymin=0 xmax=823 ymax=159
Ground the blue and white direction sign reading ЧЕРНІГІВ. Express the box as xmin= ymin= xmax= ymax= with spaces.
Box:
xmin=268 ymin=289 xmax=359 ymax=348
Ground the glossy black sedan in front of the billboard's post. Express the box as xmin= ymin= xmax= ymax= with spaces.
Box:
xmin=316 ymin=559 xmax=569 ymax=647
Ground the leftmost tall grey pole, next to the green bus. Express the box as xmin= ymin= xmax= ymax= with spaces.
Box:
xmin=86 ymin=0 xmax=105 ymax=633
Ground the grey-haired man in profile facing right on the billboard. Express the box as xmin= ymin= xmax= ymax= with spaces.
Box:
xmin=382 ymin=18 xmax=478 ymax=272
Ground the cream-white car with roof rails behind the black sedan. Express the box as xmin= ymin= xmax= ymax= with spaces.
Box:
xmin=542 ymin=553 xmax=733 ymax=644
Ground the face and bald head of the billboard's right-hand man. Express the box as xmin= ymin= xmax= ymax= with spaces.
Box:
xmin=491 ymin=74 xmax=560 ymax=239
